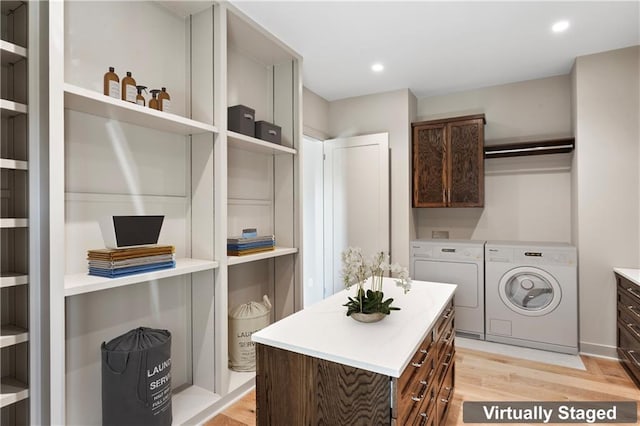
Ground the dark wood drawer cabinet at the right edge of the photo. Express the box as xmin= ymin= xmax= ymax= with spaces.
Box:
xmin=616 ymin=274 xmax=640 ymax=388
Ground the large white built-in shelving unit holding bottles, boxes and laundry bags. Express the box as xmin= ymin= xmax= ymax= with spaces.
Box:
xmin=47 ymin=1 xmax=302 ymax=425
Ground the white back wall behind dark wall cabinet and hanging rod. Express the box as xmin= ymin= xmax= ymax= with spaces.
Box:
xmin=414 ymin=75 xmax=572 ymax=242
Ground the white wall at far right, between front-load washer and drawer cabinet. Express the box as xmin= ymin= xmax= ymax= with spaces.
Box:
xmin=573 ymin=46 xmax=640 ymax=356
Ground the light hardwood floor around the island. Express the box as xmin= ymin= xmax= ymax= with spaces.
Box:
xmin=205 ymin=348 xmax=640 ymax=426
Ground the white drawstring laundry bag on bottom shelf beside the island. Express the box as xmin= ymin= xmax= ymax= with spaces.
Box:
xmin=229 ymin=295 xmax=271 ymax=371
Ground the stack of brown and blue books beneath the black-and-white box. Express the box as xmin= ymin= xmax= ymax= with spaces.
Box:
xmin=87 ymin=245 xmax=176 ymax=278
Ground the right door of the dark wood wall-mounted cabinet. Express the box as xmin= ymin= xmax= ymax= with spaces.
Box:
xmin=448 ymin=120 xmax=484 ymax=207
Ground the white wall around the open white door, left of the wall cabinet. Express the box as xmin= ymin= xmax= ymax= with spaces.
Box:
xmin=329 ymin=89 xmax=415 ymax=266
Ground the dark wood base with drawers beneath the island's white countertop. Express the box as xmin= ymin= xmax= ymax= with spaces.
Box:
xmin=256 ymin=300 xmax=455 ymax=426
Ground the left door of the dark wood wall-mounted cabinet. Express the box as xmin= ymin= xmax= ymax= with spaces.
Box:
xmin=413 ymin=124 xmax=447 ymax=207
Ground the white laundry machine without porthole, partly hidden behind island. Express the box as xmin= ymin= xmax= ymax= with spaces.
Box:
xmin=409 ymin=240 xmax=485 ymax=340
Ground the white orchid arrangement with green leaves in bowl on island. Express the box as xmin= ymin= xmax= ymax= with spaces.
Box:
xmin=342 ymin=247 xmax=411 ymax=316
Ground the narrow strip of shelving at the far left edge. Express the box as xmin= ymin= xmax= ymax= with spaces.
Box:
xmin=0 ymin=0 xmax=31 ymax=425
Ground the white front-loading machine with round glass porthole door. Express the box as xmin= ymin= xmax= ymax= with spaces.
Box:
xmin=485 ymin=241 xmax=578 ymax=354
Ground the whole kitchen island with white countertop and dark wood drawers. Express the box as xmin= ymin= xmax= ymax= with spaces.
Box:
xmin=252 ymin=278 xmax=456 ymax=426
